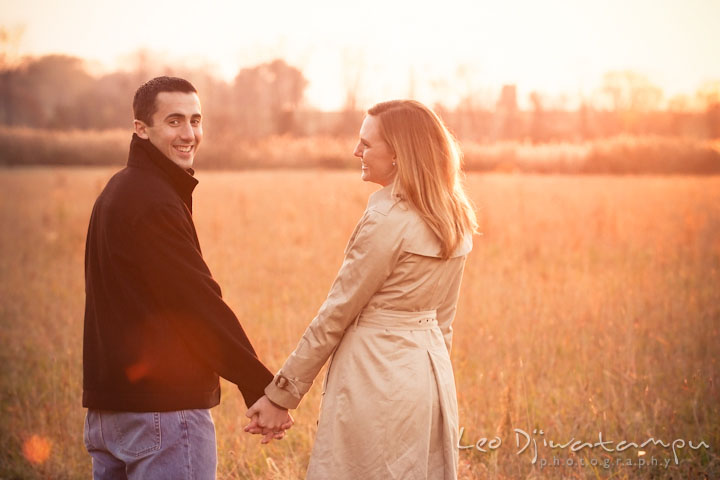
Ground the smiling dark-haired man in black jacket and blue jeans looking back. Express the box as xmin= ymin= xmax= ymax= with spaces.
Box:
xmin=83 ymin=77 xmax=292 ymax=479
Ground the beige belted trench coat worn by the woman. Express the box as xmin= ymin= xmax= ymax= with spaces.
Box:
xmin=265 ymin=182 xmax=472 ymax=480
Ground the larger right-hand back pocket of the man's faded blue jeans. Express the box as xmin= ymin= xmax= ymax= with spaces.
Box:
xmin=108 ymin=412 xmax=162 ymax=457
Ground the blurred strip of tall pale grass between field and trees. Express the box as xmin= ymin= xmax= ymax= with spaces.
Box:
xmin=0 ymin=126 xmax=720 ymax=175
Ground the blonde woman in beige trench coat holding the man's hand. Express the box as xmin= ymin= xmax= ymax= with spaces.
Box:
xmin=248 ymin=100 xmax=476 ymax=479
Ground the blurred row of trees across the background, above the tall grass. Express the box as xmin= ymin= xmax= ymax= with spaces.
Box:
xmin=0 ymin=53 xmax=720 ymax=143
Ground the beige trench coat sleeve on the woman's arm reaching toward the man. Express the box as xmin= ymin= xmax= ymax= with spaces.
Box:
xmin=265 ymin=210 xmax=401 ymax=408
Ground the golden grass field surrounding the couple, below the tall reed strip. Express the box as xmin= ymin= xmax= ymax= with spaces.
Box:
xmin=0 ymin=167 xmax=720 ymax=479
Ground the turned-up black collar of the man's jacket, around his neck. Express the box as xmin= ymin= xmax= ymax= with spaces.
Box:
xmin=127 ymin=133 xmax=198 ymax=210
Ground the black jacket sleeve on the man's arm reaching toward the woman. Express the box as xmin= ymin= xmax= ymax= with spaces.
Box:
xmin=135 ymin=201 xmax=272 ymax=405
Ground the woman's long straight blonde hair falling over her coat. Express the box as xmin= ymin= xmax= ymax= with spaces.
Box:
xmin=368 ymin=100 xmax=477 ymax=259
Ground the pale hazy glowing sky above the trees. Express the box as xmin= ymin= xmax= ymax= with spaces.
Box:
xmin=0 ymin=0 xmax=720 ymax=108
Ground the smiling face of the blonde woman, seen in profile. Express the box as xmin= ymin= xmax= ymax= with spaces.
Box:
xmin=353 ymin=115 xmax=397 ymax=187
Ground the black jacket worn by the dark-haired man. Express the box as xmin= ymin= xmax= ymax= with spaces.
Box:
xmin=83 ymin=135 xmax=273 ymax=412
